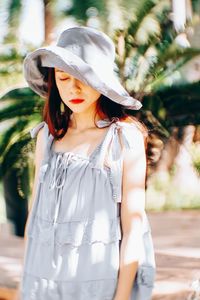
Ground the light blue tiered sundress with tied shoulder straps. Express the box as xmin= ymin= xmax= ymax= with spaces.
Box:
xmin=20 ymin=118 xmax=154 ymax=300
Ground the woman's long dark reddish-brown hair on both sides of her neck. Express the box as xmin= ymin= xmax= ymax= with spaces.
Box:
xmin=43 ymin=68 xmax=148 ymax=148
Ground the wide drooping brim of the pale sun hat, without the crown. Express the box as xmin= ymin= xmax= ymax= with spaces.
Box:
xmin=23 ymin=45 xmax=142 ymax=110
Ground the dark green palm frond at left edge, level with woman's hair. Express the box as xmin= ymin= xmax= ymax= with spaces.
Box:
xmin=0 ymin=88 xmax=44 ymax=176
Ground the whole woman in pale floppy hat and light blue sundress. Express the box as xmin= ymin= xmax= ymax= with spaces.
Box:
xmin=20 ymin=26 xmax=155 ymax=300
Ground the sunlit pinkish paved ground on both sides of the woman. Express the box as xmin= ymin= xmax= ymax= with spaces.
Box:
xmin=0 ymin=211 xmax=200 ymax=300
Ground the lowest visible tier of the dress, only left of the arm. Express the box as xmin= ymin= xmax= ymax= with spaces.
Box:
xmin=21 ymin=273 xmax=117 ymax=300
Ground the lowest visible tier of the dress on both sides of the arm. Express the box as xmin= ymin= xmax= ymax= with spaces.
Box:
xmin=21 ymin=265 xmax=155 ymax=300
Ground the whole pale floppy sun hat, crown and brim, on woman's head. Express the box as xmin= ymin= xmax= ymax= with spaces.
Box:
xmin=23 ymin=26 xmax=142 ymax=110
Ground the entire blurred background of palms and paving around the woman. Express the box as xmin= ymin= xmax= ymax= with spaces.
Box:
xmin=0 ymin=0 xmax=200 ymax=300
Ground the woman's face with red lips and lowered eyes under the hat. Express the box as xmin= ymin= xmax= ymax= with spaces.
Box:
xmin=54 ymin=68 xmax=101 ymax=112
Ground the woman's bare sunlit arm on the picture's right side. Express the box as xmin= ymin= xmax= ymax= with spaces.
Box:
xmin=114 ymin=126 xmax=146 ymax=300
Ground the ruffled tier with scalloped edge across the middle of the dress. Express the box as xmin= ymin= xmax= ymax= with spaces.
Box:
xmin=27 ymin=216 xmax=121 ymax=247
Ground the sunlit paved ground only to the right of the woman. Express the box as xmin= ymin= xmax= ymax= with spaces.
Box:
xmin=149 ymin=211 xmax=200 ymax=300
